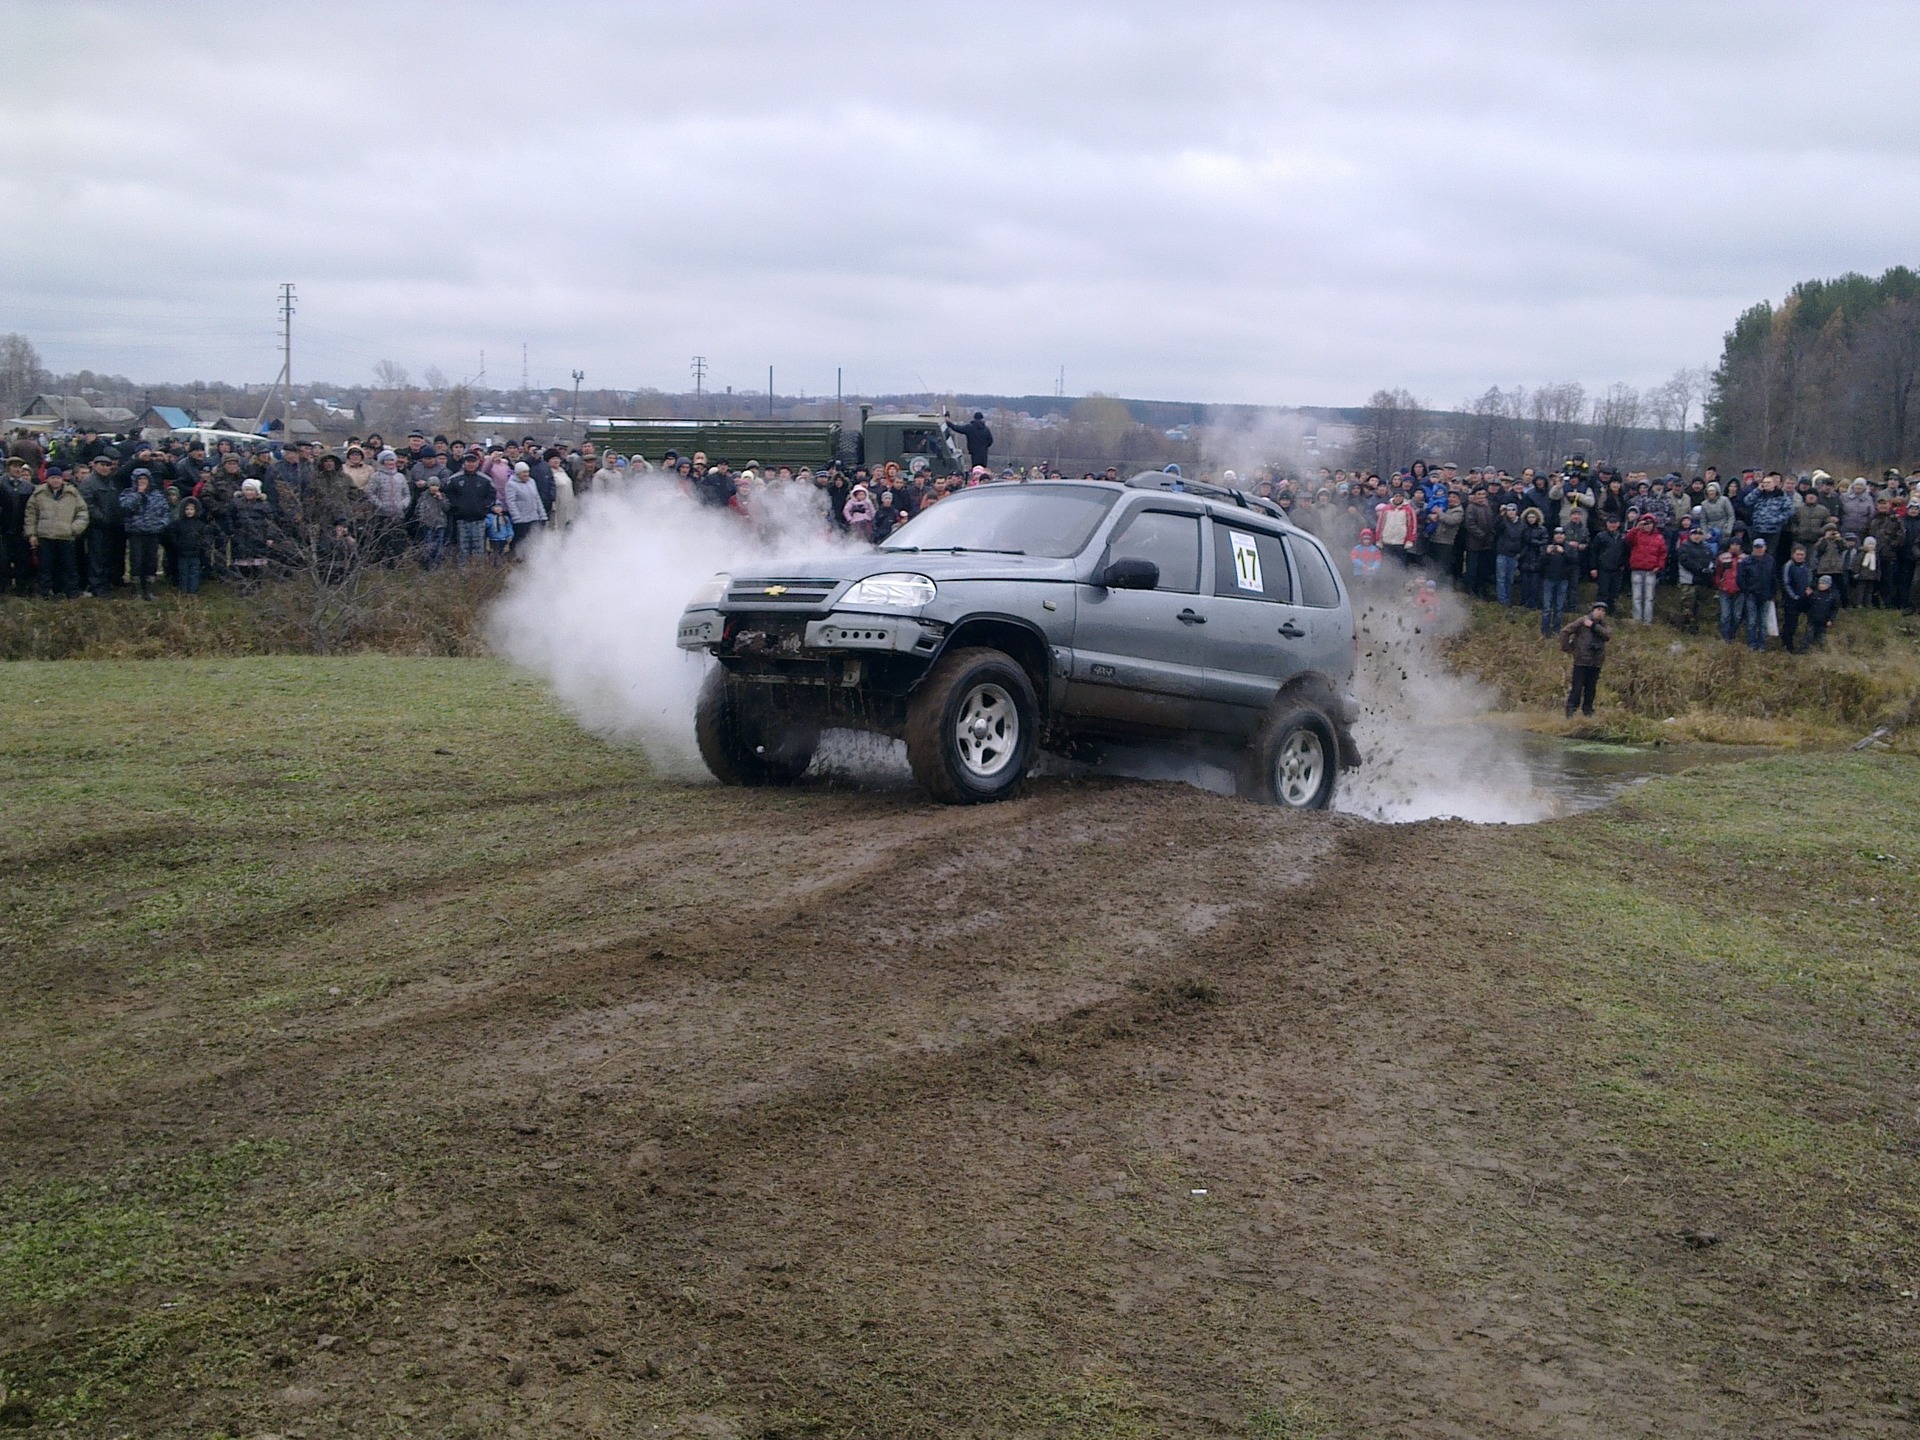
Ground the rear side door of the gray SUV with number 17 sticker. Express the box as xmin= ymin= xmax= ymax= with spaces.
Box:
xmin=1194 ymin=518 xmax=1313 ymax=737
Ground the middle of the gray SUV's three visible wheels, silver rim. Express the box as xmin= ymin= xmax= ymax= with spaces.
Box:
xmin=906 ymin=647 xmax=1041 ymax=804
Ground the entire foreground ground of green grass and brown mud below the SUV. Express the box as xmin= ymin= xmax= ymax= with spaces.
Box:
xmin=0 ymin=657 xmax=1920 ymax=1438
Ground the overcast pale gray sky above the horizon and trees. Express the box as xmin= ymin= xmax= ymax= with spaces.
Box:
xmin=0 ymin=0 xmax=1920 ymax=405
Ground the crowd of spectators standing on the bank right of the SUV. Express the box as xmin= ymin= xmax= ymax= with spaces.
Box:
xmin=1271 ymin=455 xmax=1920 ymax=651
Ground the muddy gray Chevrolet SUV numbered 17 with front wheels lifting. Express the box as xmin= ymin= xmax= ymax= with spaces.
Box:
xmin=680 ymin=472 xmax=1359 ymax=808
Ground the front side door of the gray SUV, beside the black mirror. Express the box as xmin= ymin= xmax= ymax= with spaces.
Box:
xmin=1062 ymin=501 xmax=1208 ymax=733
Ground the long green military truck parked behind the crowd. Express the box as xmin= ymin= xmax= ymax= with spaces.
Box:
xmin=588 ymin=405 xmax=968 ymax=474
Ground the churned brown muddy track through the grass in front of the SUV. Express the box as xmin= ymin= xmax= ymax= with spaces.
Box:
xmin=3 ymin=781 xmax=1827 ymax=1438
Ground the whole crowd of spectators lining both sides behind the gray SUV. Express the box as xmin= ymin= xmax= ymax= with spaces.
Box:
xmin=0 ymin=428 xmax=1920 ymax=651
